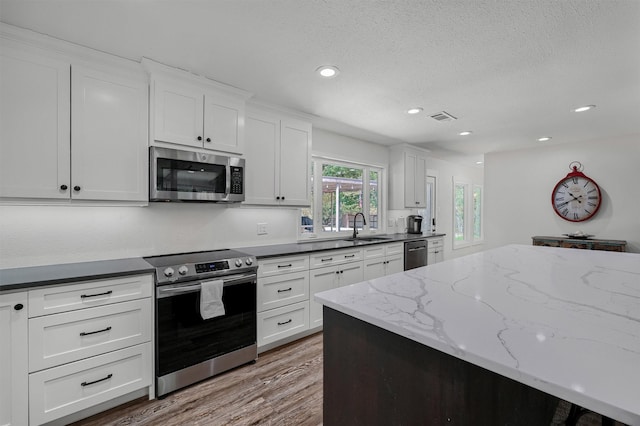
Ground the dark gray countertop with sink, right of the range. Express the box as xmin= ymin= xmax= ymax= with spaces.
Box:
xmin=237 ymin=233 xmax=446 ymax=259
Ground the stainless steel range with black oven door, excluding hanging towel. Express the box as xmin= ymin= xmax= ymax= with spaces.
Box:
xmin=145 ymin=250 xmax=258 ymax=396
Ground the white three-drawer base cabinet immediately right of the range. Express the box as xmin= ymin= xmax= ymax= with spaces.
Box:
xmin=257 ymin=256 xmax=309 ymax=351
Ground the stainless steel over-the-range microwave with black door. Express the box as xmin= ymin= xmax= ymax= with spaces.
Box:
xmin=149 ymin=146 xmax=244 ymax=203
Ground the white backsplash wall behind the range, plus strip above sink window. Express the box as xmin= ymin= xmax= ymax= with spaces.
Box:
xmin=0 ymin=129 xmax=388 ymax=268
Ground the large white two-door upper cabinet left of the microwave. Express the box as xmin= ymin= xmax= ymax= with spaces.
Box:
xmin=0 ymin=26 xmax=148 ymax=203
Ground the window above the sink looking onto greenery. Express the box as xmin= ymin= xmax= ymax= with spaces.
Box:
xmin=300 ymin=158 xmax=383 ymax=238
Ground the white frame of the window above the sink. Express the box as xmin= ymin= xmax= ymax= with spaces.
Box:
xmin=298 ymin=155 xmax=387 ymax=240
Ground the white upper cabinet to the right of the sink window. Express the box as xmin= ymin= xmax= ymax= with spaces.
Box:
xmin=389 ymin=145 xmax=427 ymax=209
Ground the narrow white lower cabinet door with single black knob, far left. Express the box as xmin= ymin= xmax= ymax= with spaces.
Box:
xmin=0 ymin=291 xmax=29 ymax=426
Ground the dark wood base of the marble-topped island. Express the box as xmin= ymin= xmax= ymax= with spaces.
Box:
xmin=323 ymin=306 xmax=559 ymax=426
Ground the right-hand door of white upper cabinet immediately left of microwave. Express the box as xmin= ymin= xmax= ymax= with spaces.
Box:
xmin=71 ymin=65 xmax=148 ymax=201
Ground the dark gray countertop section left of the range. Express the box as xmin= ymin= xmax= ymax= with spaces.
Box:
xmin=0 ymin=257 xmax=154 ymax=292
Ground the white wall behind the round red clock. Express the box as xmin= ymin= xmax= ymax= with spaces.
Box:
xmin=484 ymin=134 xmax=640 ymax=253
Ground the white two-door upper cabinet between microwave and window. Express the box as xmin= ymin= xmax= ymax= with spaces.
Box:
xmin=245 ymin=108 xmax=311 ymax=206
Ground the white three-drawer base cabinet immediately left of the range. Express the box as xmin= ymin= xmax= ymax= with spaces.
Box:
xmin=23 ymin=275 xmax=154 ymax=426
